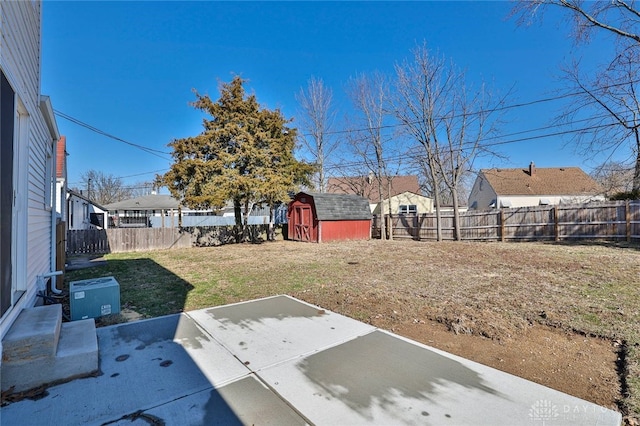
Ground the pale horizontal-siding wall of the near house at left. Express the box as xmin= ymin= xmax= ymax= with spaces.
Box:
xmin=0 ymin=1 xmax=58 ymax=337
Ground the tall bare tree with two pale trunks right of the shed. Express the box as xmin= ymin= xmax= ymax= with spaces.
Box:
xmin=394 ymin=44 xmax=504 ymax=241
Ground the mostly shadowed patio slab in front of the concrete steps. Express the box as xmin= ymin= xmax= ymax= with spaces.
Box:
xmin=0 ymin=315 xmax=250 ymax=425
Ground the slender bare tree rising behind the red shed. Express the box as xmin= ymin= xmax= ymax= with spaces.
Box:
xmin=296 ymin=77 xmax=338 ymax=192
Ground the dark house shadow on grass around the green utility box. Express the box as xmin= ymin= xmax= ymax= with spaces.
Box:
xmin=63 ymin=258 xmax=194 ymax=326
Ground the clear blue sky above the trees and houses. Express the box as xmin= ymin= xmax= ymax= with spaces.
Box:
xmin=42 ymin=0 xmax=626 ymax=191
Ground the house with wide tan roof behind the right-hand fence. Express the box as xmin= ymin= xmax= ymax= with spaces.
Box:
xmin=468 ymin=162 xmax=605 ymax=210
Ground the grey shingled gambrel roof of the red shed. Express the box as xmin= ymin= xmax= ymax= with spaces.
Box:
xmin=307 ymin=193 xmax=371 ymax=220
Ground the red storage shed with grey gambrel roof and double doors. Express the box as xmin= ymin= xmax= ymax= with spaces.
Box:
xmin=287 ymin=192 xmax=371 ymax=243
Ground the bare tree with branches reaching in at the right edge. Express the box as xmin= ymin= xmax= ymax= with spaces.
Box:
xmin=512 ymin=0 xmax=640 ymax=191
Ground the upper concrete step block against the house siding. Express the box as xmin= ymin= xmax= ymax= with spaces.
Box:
xmin=2 ymin=304 xmax=62 ymax=364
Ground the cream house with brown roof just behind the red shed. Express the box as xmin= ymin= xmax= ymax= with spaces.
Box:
xmin=327 ymin=175 xmax=433 ymax=214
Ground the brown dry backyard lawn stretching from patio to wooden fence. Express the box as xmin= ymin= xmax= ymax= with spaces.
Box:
xmin=66 ymin=240 xmax=640 ymax=424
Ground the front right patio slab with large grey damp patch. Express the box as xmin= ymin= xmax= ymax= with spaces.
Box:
xmin=255 ymin=331 xmax=621 ymax=425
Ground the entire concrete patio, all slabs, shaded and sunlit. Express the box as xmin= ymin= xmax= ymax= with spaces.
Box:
xmin=0 ymin=296 xmax=621 ymax=425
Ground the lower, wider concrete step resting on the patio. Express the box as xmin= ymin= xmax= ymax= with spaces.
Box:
xmin=0 ymin=305 xmax=98 ymax=392
